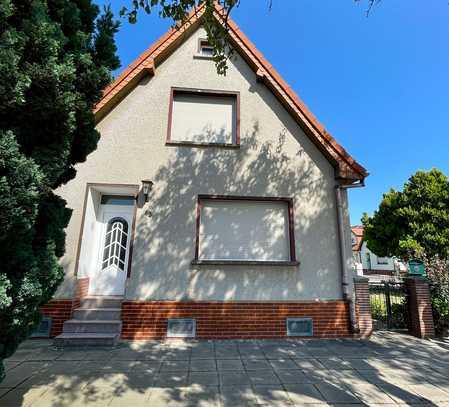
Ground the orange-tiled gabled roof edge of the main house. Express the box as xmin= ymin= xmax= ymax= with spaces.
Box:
xmin=94 ymin=5 xmax=368 ymax=183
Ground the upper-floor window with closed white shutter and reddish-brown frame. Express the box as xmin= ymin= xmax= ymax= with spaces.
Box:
xmin=167 ymin=88 xmax=240 ymax=147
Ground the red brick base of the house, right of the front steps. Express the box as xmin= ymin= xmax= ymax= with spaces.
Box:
xmin=122 ymin=300 xmax=351 ymax=339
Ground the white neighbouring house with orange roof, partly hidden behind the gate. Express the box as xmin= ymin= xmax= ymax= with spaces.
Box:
xmin=351 ymin=225 xmax=407 ymax=282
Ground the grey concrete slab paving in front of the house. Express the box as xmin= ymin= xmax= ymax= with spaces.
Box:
xmin=0 ymin=333 xmax=449 ymax=407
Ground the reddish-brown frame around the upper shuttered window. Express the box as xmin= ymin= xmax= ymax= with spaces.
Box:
xmin=165 ymin=87 xmax=240 ymax=148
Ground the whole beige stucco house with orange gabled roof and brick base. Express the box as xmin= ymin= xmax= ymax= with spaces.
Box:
xmin=43 ymin=8 xmax=367 ymax=343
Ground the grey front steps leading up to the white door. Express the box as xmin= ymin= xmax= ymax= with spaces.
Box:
xmin=54 ymin=296 xmax=123 ymax=347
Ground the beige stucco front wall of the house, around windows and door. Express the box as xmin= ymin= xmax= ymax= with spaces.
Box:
xmin=53 ymin=24 xmax=350 ymax=300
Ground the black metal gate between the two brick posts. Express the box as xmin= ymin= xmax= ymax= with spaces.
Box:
xmin=369 ymin=282 xmax=408 ymax=330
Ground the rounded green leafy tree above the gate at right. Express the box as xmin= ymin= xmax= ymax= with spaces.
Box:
xmin=362 ymin=169 xmax=449 ymax=260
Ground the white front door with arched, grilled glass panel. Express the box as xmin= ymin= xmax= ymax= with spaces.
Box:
xmin=89 ymin=205 xmax=133 ymax=295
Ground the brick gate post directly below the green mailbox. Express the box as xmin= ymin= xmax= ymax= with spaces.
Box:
xmin=405 ymin=277 xmax=435 ymax=338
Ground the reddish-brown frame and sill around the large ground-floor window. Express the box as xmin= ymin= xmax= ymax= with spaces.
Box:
xmin=192 ymin=194 xmax=299 ymax=266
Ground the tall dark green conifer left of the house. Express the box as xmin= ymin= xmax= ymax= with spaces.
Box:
xmin=0 ymin=0 xmax=119 ymax=380
